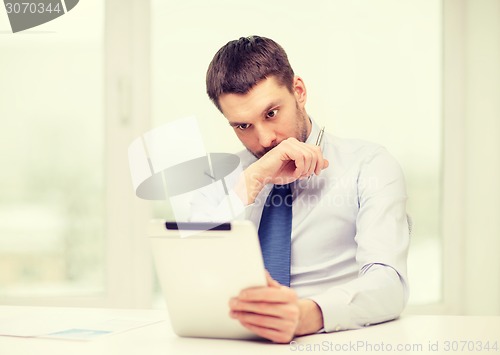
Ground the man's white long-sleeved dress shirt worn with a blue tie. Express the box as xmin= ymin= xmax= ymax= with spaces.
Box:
xmin=192 ymin=121 xmax=409 ymax=332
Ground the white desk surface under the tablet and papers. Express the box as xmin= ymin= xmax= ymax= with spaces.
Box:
xmin=0 ymin=306 xmax=500 ymax=355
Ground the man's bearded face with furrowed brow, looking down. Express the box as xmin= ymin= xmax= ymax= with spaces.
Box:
xmin=219 ymin=77 xmax=311 ymax=158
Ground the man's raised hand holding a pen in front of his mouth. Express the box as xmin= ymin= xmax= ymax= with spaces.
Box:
xmin=240 ymin=137 xmax=329 ymax=204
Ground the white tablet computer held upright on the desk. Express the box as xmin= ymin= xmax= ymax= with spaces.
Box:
xmin=149 ymin=220 xmax=266 ymax=339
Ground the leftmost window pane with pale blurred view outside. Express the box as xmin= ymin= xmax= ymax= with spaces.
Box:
xmin=0 ymin=0 xmax=106 ymax=299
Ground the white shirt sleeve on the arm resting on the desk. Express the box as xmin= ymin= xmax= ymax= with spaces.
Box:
xmin=309 ymin=148 xmax=409 ymax=332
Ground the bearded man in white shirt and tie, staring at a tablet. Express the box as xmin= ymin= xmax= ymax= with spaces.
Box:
xmin=202 ymin=36 xmax=409 ymax=343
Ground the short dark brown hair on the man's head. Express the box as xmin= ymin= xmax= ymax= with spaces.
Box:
xmin=206 ymin=36 xmax=294 ymax=112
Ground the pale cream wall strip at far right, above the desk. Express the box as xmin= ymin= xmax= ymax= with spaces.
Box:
xmin=443 ymin=0 xmax=500 ymax=315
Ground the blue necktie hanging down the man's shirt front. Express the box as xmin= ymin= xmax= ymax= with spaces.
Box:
xmin=259 ymin=184 xmax=292 ymax=286
